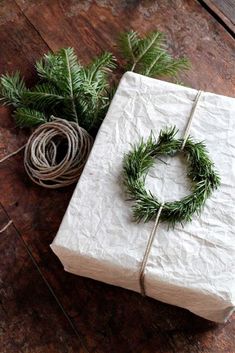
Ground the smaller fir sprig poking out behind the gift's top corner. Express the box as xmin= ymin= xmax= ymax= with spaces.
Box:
xmin=120 ymin=31 xmax=189 ymax=77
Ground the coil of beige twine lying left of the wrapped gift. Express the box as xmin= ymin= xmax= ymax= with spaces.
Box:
xmin=24 ymin=118 xmax=93 ymax=189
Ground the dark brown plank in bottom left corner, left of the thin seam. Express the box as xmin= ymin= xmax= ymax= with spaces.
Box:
xmin=0 ymin=206 xmax=84 ymax=353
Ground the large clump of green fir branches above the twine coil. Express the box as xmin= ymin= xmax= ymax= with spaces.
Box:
xmin=1 ymin=48 xmax=115 ymax=131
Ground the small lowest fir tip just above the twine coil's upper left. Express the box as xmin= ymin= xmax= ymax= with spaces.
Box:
xmin=13 ymin=108 xmax=47 ymax=127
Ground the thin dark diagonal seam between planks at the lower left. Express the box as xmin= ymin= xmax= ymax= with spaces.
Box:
xmin=0 ymin=202 xmax=91 ymax=353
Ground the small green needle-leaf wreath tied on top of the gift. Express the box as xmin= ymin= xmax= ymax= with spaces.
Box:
xmin=123 ymin=127 xmax=220 ymax=226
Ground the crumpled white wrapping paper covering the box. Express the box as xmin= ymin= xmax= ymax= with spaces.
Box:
xmin=51 ymin=72 xmax=235 ymax=322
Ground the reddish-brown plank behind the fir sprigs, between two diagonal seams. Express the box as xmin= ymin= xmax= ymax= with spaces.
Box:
xmin=13 ymin=0 xmax=235 ymax=96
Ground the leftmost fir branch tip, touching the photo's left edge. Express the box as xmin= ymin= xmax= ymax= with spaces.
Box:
xmin=0 ymin=71 xmax=27 ymax=107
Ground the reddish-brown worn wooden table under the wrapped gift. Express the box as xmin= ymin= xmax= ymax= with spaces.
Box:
xmin=0 ymin=0 xmax=235 ymax=353
